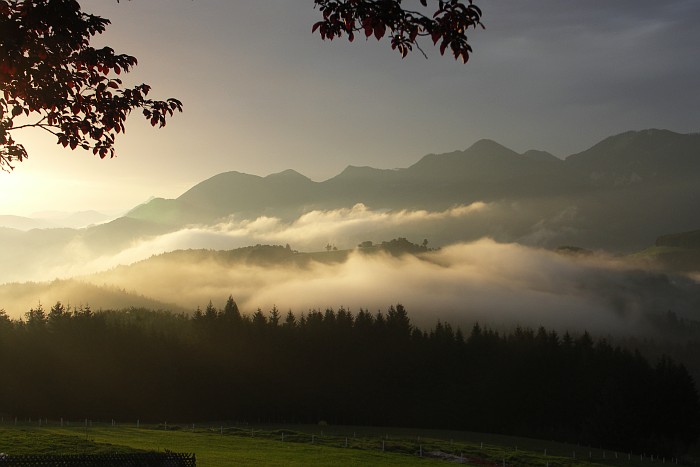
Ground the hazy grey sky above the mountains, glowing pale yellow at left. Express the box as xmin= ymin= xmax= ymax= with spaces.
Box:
xmin=0 ymin=0 xmax=700 ymax=216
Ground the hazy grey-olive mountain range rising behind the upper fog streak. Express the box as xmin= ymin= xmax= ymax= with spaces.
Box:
xmin=125 ymin=130 xmax=700 ymax=250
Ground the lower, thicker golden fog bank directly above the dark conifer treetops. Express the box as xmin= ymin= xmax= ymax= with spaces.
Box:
xmin=71 ymin=239 xmax=698 ymax=333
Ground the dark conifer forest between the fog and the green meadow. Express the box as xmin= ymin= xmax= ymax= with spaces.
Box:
xmin=0 ymin=297 xmax=700 ymax=455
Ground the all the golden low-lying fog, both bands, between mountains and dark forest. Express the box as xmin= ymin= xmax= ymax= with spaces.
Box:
xmin=0 ymin=203 xmax=700 ymax=332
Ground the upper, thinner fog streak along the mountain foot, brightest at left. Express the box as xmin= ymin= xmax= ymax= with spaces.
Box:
xmin=0 ymin=202 xmax=576 ymax=283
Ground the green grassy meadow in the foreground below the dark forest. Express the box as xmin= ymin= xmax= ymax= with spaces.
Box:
xmin=0 ymin=422 xmax=688 ymax=467
